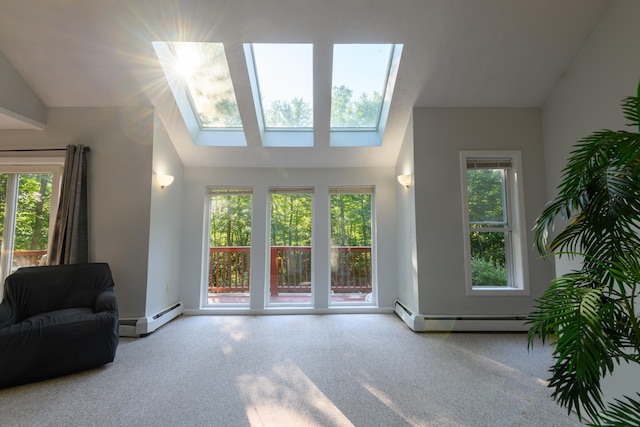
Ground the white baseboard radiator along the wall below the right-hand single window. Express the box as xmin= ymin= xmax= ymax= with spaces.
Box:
xmin=394 ymin=300 xmax=529 ymax=332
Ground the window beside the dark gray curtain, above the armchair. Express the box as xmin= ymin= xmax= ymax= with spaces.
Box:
xmin=0 ymin=165 xmax=62 ymax=298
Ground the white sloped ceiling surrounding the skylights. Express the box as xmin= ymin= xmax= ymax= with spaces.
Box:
xmin=0 ymin=0 xmax=610 ymax=167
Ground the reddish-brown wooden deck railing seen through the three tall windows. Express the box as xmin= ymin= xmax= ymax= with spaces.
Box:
xmin=209 ymin=246 xmax=371 ymax=296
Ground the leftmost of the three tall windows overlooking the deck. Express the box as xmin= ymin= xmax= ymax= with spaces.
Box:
xmin=207 ymin=188 xmax=252 ymax=304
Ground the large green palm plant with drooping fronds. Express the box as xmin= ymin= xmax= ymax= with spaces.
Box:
xmin=528 ymin=84 xmax=640 ymax=426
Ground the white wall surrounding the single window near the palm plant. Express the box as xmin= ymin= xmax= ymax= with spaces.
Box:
xmin=413 ymin=108 xmax=551 ymax=316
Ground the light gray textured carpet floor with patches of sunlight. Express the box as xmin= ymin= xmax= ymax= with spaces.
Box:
xmin=0 ymin=314 xmax=580 ymax=427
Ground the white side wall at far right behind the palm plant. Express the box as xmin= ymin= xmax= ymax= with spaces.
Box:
xmin=543 ymin=0 xmax=640 ymax=412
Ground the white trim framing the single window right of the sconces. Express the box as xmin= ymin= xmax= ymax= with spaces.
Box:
xmin=460 ymin=150 xmax=530 ymax=296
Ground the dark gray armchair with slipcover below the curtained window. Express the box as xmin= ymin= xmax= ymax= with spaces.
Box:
xmin=0 ymin=263 xmax=118 ymax=388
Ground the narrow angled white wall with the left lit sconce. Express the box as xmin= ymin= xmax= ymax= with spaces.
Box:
xmin=145 ymin=113 xmax=183 ymax=316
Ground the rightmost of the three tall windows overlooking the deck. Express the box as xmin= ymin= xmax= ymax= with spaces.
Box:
xmin=329 ymin=187 xmax=373 ymax=304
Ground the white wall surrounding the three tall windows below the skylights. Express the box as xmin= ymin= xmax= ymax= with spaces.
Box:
xmin=180 ymin=168 xmax=397 ymax=311
